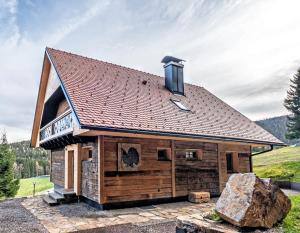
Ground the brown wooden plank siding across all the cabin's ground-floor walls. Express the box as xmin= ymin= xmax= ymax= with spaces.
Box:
xmin=51 ymin=136 xmax=250 ymax=204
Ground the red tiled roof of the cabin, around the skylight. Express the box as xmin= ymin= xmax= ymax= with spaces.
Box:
xmin=47 ymin=48 xmax=282 ymax=144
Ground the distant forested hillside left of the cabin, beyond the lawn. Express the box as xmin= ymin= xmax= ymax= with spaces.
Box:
xmin=10 ymin=141 xmax=50 ymax=178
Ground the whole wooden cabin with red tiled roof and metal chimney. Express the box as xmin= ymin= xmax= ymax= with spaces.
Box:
xmin=31 ymin=48 xmax=283 ymax=208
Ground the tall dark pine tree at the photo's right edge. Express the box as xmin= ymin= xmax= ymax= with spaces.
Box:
xmin=284 ymin=69 xmax=300 ymax=139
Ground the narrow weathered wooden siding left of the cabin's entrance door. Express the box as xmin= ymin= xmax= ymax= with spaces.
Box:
xmin=51 ymin=149 xmax=65 ymax=187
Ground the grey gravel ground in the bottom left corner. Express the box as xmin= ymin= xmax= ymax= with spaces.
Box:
xmin=0 ymin=198 xmax=48 ymax=233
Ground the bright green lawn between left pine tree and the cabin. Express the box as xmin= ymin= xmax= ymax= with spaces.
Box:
xmin=17 ymin=176 xmax=53 ymax=197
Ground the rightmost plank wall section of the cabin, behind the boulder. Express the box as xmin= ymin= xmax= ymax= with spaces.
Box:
xmin=218 ymin=144 xmax=251 ymax=192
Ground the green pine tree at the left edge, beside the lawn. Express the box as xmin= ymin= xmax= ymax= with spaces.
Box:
xmin=0 ymin=133 xmax=20 ymax=198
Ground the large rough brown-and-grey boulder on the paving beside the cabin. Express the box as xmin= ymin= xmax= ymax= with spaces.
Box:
xmin=216 ymin=173 xmax=291 ymax=228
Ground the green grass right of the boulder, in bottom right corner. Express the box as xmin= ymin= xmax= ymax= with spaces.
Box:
xmin=282 ymin=195 xmax=300 ymax=233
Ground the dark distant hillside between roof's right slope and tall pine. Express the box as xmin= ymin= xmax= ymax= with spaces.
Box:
xmin=256 ymin=116 xmax=300 ymax=145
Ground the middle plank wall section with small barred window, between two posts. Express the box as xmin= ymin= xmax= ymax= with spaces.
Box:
xmin=175 ymin=141 xmax=219 ymax=197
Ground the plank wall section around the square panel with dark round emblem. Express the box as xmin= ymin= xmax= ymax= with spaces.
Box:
xmin=104 ymin=136 xmax=172 ymax=203
